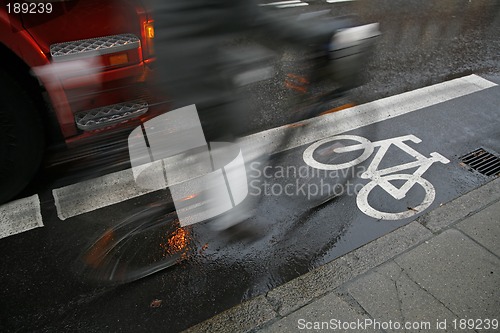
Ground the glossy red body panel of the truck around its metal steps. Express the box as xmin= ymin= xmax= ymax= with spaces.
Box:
xmin=0 ymin=0 xmax=165 ymax=144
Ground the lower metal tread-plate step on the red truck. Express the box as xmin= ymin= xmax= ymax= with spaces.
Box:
xmin=75 ymin=100 xmax=149 ymax=131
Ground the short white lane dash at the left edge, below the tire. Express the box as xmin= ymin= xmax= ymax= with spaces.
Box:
xmin=0 ymin=194 xmax=43 ymax=239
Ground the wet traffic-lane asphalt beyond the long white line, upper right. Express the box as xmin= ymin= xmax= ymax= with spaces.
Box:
xmin=244 ymin=0 xmax=500 ymax=130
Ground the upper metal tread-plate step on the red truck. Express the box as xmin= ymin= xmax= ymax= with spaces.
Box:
xmin=50 ymin=34 xmax=141 ymax=62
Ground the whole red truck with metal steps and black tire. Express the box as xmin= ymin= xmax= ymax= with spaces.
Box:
xmin=0 ymin=0 xmax=163 ymax=203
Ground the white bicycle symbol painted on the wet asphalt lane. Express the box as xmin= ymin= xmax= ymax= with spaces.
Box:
xmin=303 ymin=135 xmax=450 ymax=220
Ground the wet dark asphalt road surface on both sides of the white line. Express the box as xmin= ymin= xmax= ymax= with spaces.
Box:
xmin=0 ymin=0 xmax=500 ymax=332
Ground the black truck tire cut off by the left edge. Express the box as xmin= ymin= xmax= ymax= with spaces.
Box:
xmin=0 ymin=70 xmax=45 ymax=204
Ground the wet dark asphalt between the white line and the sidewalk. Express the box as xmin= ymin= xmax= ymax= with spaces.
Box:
xmin=0 ymin=81 xmax=500 ymax=332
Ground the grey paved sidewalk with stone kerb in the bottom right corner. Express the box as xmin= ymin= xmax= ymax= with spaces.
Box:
xmin=186 ymin=179 xmax=500 ymax=333
